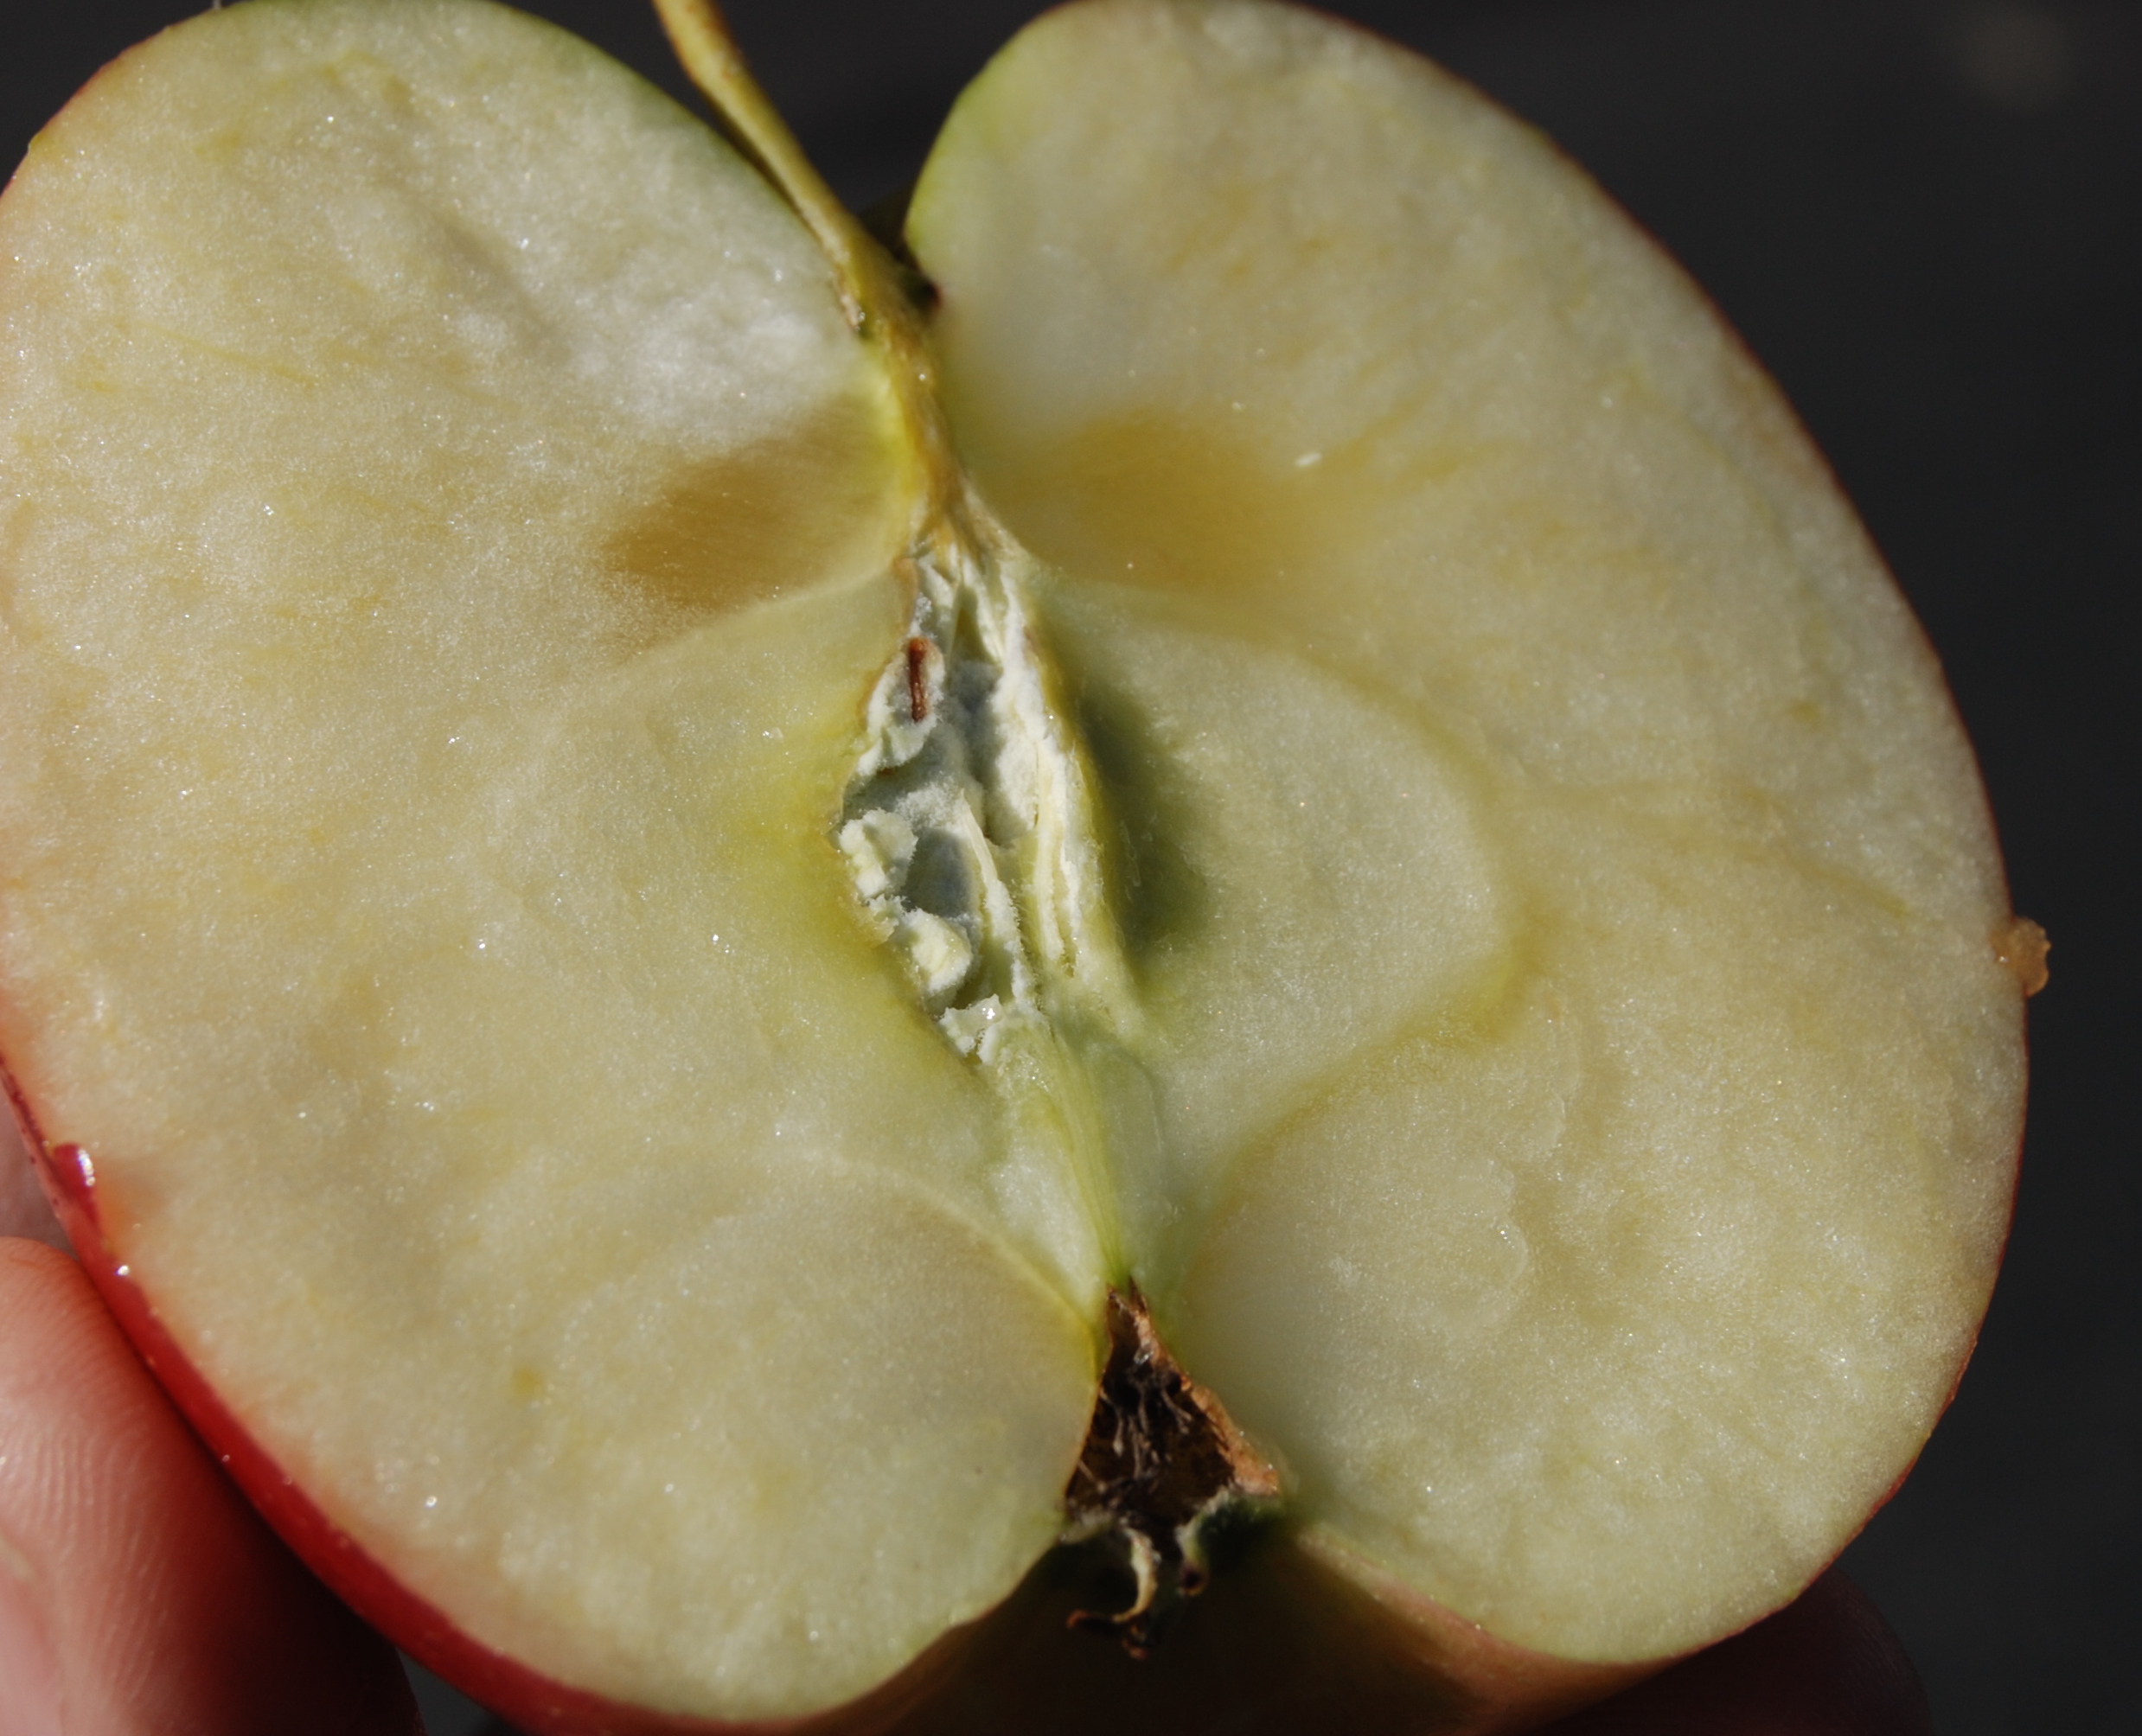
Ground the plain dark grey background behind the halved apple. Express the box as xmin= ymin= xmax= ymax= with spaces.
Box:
xmin=0 ymin=0 xmax=2142 ymax=1736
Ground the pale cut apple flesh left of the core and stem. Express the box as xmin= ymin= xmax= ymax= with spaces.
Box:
xmin=0 ymin=4 xmax=1097 ymax=1717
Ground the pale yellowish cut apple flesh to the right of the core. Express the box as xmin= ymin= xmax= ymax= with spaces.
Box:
xmin=908 ymin=0 xmax=2022 ymax=1659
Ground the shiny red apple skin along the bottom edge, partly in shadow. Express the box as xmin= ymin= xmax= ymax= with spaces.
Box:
xmin=0 ymin=1044 xmax=1673 ymax=1736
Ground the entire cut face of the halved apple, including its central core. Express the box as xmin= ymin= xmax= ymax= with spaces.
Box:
xmin=0 ymin=0 xmax=2022 ymax=1730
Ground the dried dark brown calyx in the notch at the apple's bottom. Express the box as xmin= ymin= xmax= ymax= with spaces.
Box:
xmin=1065 ymin=1285 xmax=1279 ymax=1656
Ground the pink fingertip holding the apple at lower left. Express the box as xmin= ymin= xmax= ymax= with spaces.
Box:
xmin=0 ymin=1240 xmax=422 ymax=1736
